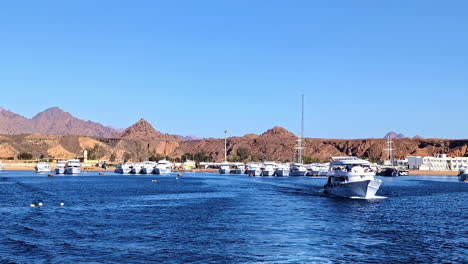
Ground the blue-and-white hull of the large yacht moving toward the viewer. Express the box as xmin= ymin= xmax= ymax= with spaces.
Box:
xmin=324 ymin=180 xmax=382 ymax=199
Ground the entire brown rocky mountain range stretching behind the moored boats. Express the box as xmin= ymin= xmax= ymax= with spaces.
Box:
xmin=0 ymin=109 xmax=468 ymax=161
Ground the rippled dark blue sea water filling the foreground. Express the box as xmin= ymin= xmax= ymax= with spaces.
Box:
xmin=0 ymin=171 xmax=468 ymax=263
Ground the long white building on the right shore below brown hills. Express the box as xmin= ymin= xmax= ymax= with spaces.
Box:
xmin=406 ymin=154 xmax=468 ymax=171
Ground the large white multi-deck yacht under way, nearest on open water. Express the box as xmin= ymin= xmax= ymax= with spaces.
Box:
xmin=323 ymin=157 xmax=382 ymax=199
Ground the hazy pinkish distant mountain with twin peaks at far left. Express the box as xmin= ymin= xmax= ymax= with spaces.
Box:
xmin=0 ymin=107 xmax=118 ymax=137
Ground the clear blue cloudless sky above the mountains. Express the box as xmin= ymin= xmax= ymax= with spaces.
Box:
xmin=0 ymin=0 xmax=468 ymax=138
